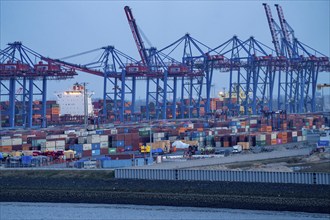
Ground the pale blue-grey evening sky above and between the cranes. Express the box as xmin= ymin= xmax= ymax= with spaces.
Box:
xmin=0 ymin=0 xmax=330 ymax=98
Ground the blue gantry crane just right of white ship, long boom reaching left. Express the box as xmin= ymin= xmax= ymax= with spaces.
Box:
xmin=42 ymin=46 xmax=142 ymax=122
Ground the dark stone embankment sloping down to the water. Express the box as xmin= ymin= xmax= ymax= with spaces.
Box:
xmin=0 ymin=170 xmax=330 ymax=213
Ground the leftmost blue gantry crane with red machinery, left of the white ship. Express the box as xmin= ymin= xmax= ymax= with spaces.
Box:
xmin=0 ymin=42 xmax=77 ymax=127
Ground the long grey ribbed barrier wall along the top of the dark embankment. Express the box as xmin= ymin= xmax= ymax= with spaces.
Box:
xmin=115 ymin=169 xmax=330 ymax=185
